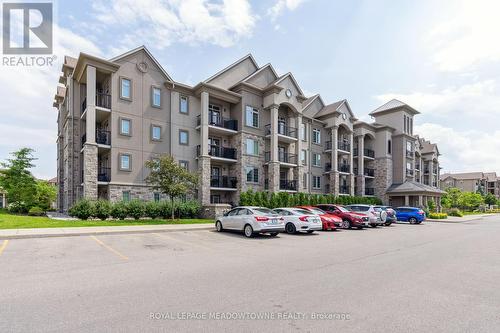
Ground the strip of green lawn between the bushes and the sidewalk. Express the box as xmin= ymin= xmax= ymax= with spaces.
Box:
xmin=0 ymin=211 xmax=213 ymax=229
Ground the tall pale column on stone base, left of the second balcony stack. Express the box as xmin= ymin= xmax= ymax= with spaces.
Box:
xmin=198 ymin=91 xmax=211 ymax=206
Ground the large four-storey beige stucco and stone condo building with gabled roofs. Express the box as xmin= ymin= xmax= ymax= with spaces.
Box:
xmin=54 ymin=47 xmax=441 ymax=211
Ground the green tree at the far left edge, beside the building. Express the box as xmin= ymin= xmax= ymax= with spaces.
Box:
xmin=0 ymin=148 xmax=37 ymax=212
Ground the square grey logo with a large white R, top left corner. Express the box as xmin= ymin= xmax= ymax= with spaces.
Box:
xmin=2 ymin=3 xmax=53 ymax=54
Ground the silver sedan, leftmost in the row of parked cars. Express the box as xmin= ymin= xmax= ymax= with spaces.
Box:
xmin=215 ymin=207 xmax=285 ymax=237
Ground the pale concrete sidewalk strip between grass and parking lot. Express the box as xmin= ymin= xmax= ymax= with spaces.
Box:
xmin=0 ymin=223 xmax=214 ymax=240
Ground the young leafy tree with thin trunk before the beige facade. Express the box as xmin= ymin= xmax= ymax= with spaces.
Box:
xmin=146 ymin=155 xmax=198 ymax=220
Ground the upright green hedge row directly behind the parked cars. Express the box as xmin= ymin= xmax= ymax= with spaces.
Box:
xmin=240 ymin=190 xmax=382 ymax=208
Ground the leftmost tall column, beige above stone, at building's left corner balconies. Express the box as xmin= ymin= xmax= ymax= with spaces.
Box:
xmin=83 ymin=66 xmax=97 ymax=200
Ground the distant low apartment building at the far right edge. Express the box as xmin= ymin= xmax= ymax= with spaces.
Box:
xmin=440 ymin=172 xmax=500 ymax=199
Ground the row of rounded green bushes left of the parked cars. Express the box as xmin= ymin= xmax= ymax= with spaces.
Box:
xmin=68 ymin=199 xmax=201 ymax=220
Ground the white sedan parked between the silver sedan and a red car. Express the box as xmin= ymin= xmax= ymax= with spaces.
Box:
xmin=273 ymin=208 xmax=323 ymax=234
